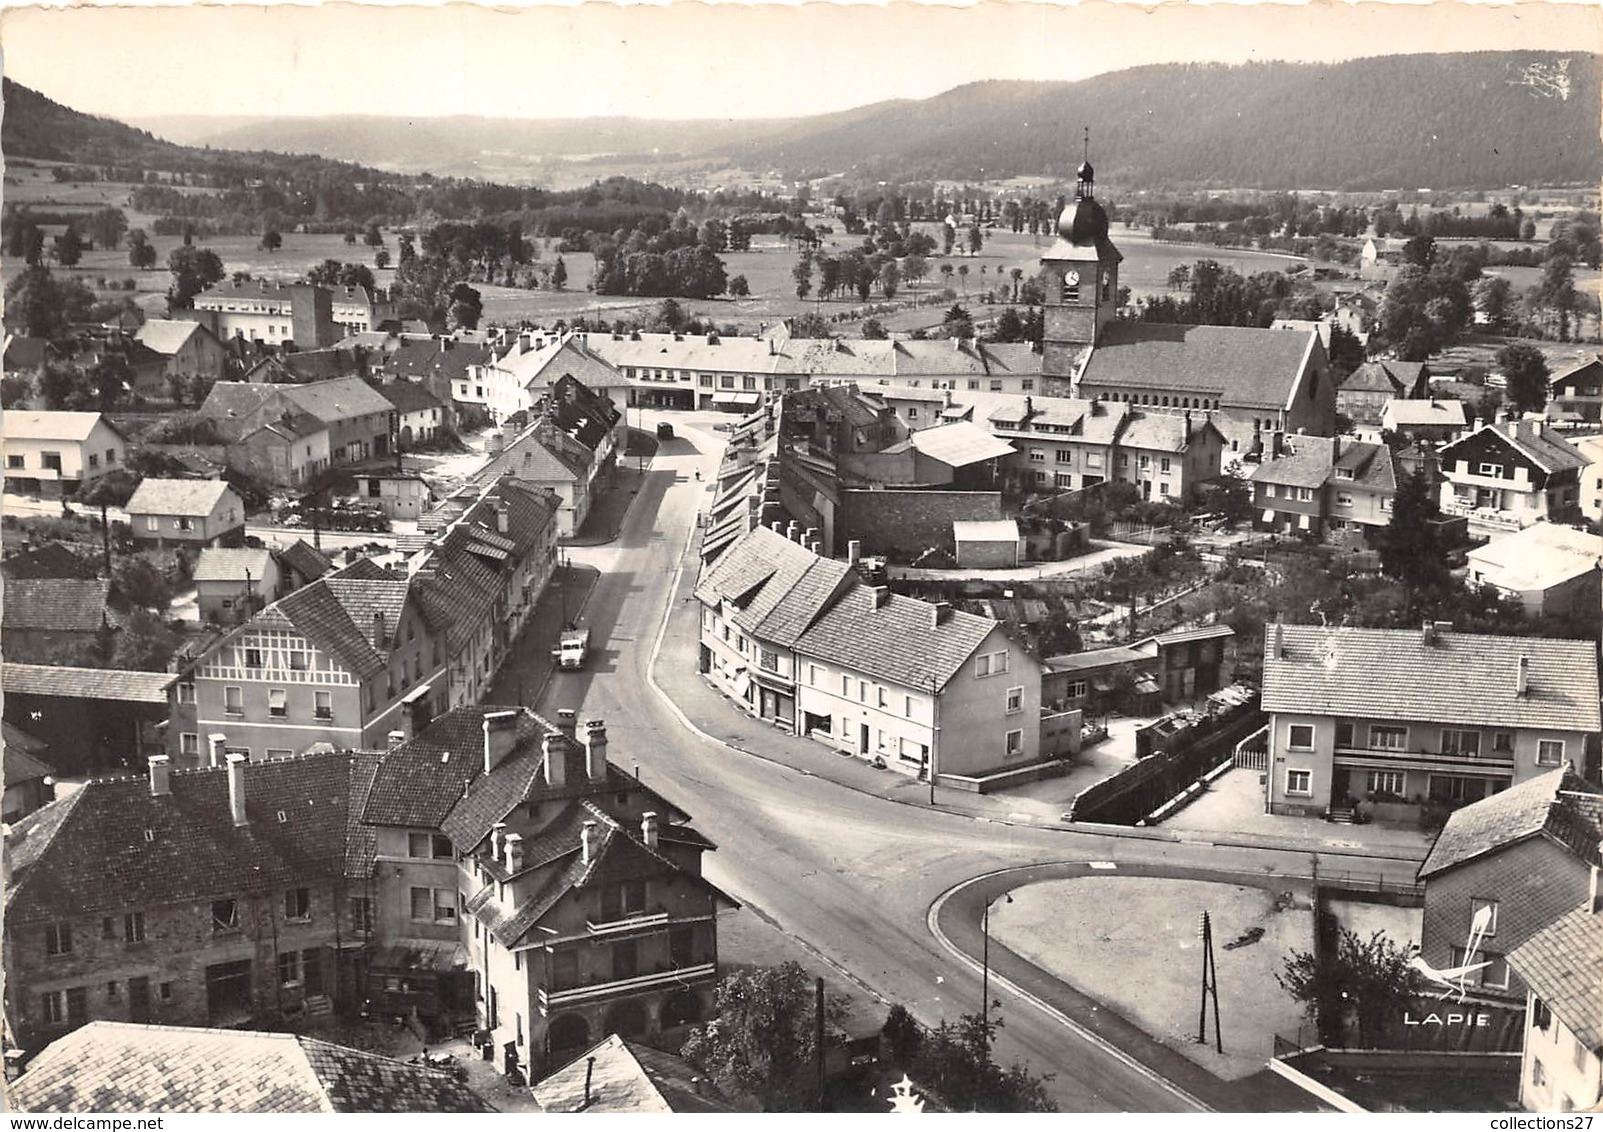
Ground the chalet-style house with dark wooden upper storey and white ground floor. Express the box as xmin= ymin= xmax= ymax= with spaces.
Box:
xmin=1439 ymin=420 xmax=1587 ymax=534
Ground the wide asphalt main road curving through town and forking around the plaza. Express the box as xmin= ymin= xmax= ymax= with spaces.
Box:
xmin=540 ymin=412 xmax=1410 ymax=1111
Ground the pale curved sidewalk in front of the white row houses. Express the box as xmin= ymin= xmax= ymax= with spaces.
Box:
xmin=652 ymin=540 xmax=1430 ymax=859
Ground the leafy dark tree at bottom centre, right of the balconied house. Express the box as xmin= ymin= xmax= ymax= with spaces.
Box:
xmin=680 ymin=962 xmax=845 ymax=1113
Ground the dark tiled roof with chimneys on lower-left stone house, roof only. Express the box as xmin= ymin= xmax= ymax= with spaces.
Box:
xmin=5 ymin=752 xmax=373 ymax=928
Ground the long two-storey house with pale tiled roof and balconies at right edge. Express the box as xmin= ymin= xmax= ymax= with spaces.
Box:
xmin=1263 ymin=624 xmax=1600 ymax=816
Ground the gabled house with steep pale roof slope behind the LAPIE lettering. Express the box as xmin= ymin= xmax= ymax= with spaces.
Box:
xmin=1419 ymin=768 xmax=1603 ymax=1004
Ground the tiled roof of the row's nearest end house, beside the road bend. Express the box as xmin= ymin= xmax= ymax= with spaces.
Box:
xmin=795 ymin=585 xmax=997 ymax=688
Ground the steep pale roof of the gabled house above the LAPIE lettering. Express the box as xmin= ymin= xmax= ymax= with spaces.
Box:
xmin=1419 ymin=768 xmax=1603 ymax=880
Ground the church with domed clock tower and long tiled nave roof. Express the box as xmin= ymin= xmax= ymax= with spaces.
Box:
xmin=1040 ymin=153 xmax=1335 ymax=465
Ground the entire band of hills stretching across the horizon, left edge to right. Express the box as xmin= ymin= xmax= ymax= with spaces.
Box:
xmin=15 ymin=51 xmax=1603 ymax=192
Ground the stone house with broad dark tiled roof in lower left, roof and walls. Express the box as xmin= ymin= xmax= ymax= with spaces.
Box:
xmin=3 ymin=752 xmax=372 ymax=1049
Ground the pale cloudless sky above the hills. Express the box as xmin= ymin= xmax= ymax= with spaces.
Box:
xmin=0 ymin=0 xmax=1603 ymax=119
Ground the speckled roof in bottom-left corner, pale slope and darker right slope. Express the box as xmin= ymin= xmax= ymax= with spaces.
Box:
xmin=8 ymin=1021 xmax=495 ymax=1113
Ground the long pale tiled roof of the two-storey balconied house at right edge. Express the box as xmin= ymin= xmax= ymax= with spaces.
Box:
xmin=1263 ymin=624 xmax=1600 ymax=731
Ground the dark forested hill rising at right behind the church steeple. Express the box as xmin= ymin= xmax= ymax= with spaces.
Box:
xmin=731 ymin=51 xmax=1603 ymax=189
